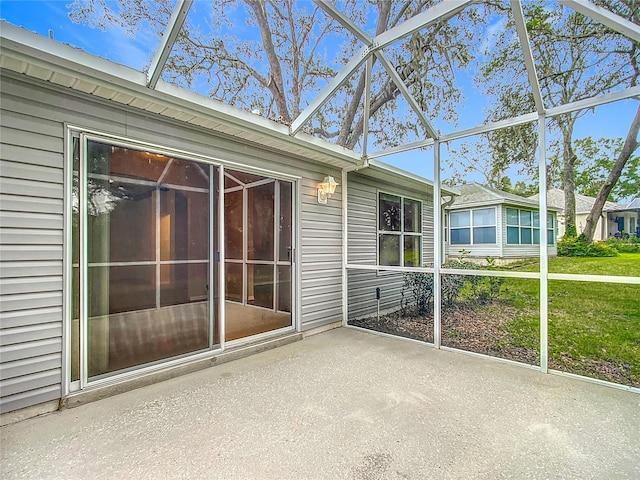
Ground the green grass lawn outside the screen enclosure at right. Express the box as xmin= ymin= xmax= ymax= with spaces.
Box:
xmin=503 ymin=253 xmax=640 ymax=387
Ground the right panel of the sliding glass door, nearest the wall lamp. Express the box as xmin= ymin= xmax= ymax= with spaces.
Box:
xmin=224 ymin=170 xmax=293 ymax=341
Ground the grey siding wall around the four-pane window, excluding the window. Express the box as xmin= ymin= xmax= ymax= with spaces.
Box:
xmin=347 ymin=172 xmax=433 ymax=319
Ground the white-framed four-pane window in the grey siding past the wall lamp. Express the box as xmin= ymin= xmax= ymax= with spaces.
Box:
xmin=378 ymin=192 xmax=422 ymax=267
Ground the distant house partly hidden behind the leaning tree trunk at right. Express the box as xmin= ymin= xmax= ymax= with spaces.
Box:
xmin=529 ymin=188 xmax=631 ymax=240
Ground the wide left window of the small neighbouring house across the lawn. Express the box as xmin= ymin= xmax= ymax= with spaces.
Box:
xmin=449 ymin=207 xmax=496 ymax=245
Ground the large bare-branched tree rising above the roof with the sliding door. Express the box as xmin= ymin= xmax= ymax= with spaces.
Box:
xmin=70 ymin=0 xmax=481 ymax=149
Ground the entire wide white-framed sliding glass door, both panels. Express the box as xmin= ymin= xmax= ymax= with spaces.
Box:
xmin=70 ymin=133 xmax=294 ymax=388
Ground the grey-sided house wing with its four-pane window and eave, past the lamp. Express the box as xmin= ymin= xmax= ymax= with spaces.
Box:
xmin=347 ymin=160 xmax=456 ymax=320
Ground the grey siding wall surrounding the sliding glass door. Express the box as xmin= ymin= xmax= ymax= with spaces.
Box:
xmin=0 ymin=74 xmax=342 ymax=412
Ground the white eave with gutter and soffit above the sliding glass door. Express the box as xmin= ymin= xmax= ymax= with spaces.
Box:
xmin=0 ymin=21 xmax=362 ymax=172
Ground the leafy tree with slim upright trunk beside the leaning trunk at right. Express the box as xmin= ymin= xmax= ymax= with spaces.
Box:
xmin=478 ymin=0 xmax=637 ymax=238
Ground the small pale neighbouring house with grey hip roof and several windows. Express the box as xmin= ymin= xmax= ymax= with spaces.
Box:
xmin=445 ymin=183 xmax=557 ymax=259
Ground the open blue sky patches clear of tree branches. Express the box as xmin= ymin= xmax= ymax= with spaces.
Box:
xmin=0 ymin=0 xmax=637 ymax=193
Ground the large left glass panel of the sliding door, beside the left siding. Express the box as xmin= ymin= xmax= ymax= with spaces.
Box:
xmin=80 ymin=141 xmax=214 ymax=379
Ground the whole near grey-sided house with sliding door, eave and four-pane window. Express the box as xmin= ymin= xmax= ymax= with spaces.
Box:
xmin=0 ymin=23 xmax=456 ymax=415
